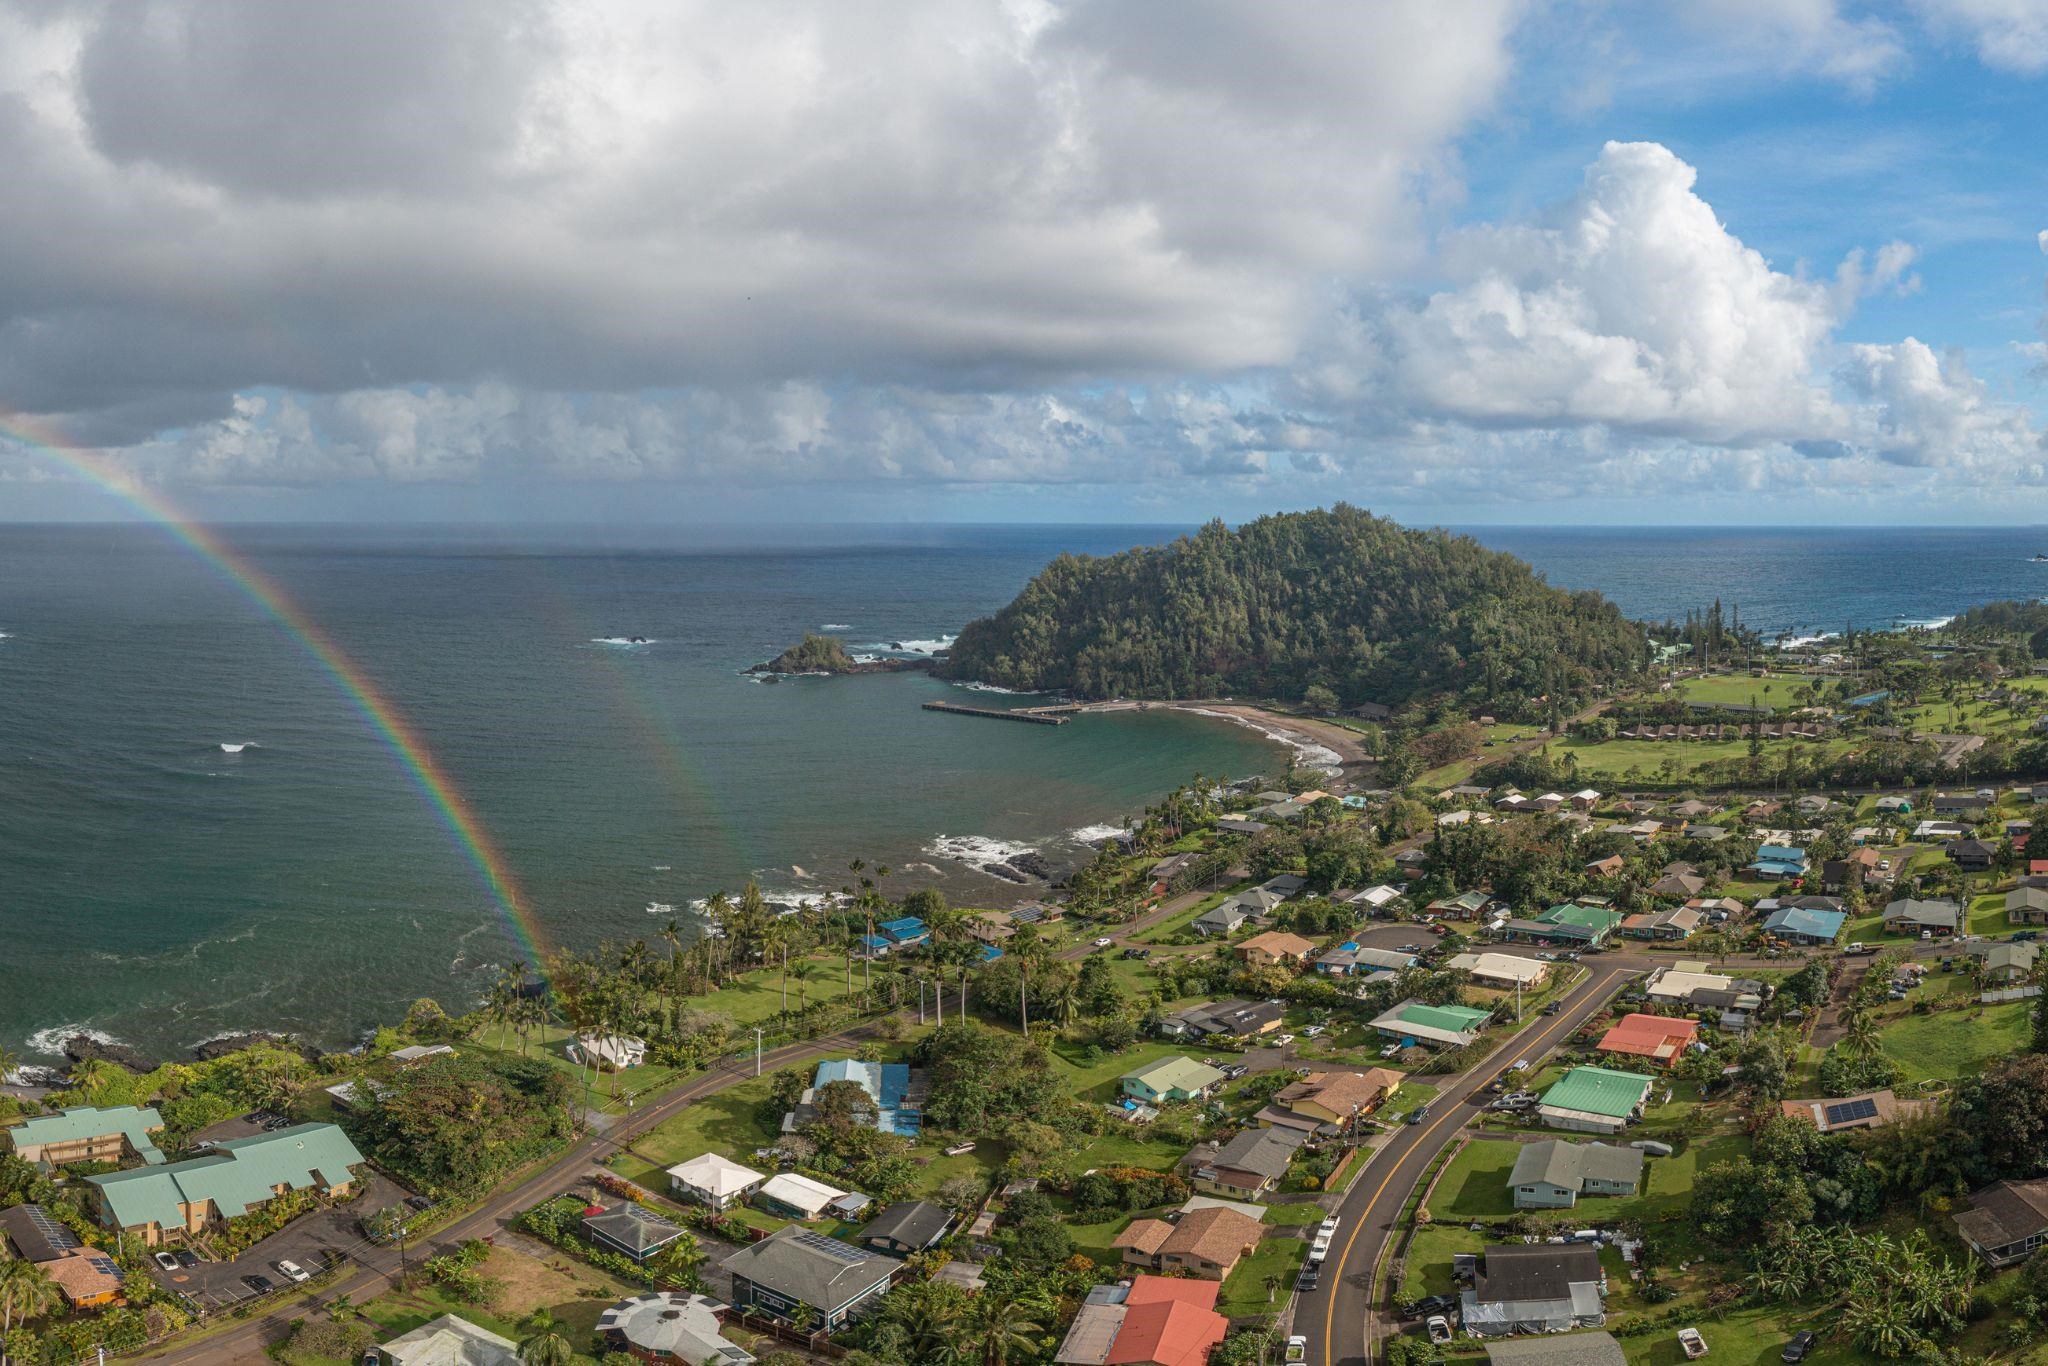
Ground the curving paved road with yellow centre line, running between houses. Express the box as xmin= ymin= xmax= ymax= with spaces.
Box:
xmin=1294 ymin=956 xmax=1640 ymax=1366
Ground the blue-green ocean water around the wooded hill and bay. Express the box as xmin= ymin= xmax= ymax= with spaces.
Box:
xmin=0 ymin=526 xmax=2048 ymax=1061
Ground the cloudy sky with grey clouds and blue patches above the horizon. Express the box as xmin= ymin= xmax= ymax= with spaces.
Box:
xmin=0 ymin=0 xmax=2048 ymax=526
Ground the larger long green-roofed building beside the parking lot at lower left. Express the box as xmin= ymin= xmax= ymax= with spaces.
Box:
xmin=86 ymin=1124 xmax=362 ymax=1247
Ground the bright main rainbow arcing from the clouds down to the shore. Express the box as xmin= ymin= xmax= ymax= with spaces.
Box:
xmin=0 ymin=410 xmax=545 ymax=967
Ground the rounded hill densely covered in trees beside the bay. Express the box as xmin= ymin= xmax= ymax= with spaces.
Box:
xmin=944 ymin=504 xmax=1649 ymax=707
